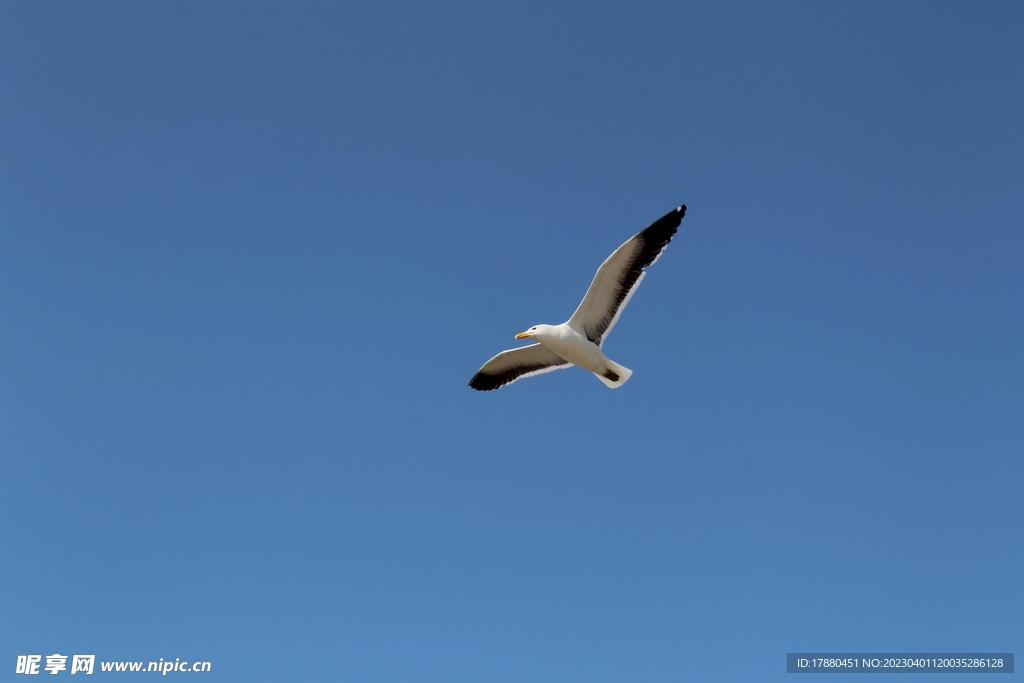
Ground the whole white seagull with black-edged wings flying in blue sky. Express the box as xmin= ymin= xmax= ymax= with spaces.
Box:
xmin=469 ymin=205 xmax=686 ymax=391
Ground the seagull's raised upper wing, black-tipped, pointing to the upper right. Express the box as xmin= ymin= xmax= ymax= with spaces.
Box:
xmin=568 ymin=205 xmax=686 ymax=346
